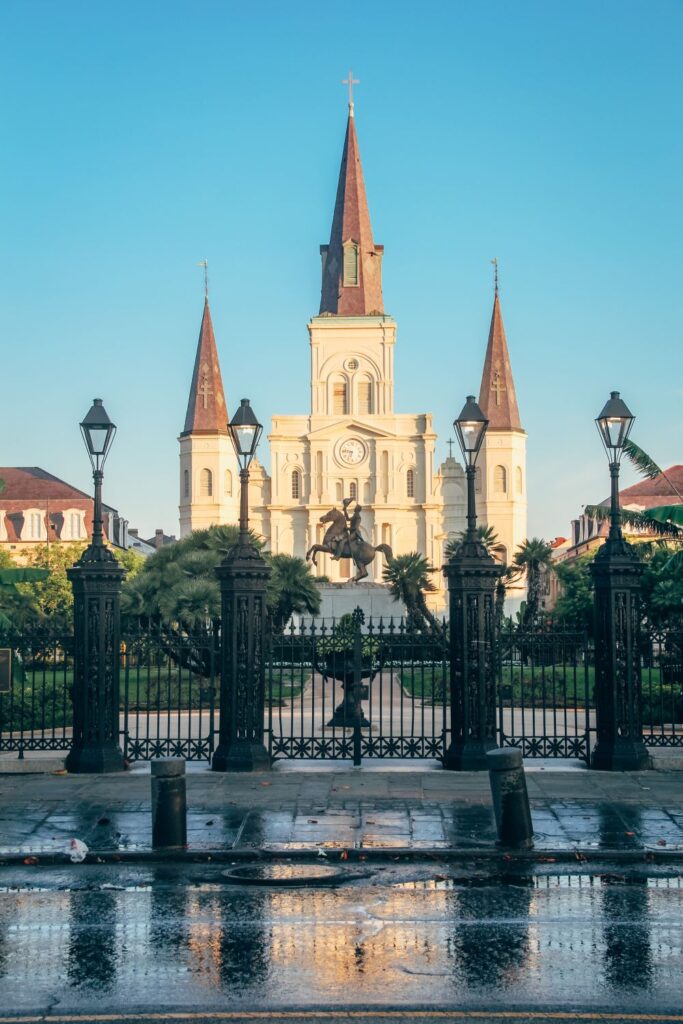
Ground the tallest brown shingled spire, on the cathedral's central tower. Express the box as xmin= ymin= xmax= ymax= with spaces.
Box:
xmin=321 ymin=103 xmax=384 ymax=316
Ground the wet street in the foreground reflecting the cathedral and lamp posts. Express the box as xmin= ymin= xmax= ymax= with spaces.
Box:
xmin=0 ymin=862 xmax=683 ymax=1019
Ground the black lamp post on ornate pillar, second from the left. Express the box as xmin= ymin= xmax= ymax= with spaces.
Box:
xmin=211 ymin=398 xmax=270 ymax=771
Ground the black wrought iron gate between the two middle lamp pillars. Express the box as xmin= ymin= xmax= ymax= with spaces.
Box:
xmin=266 ymin=620 xmax=449 ymax=764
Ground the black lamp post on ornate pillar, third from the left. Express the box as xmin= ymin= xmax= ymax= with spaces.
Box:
xmin=443 ymin=395 xmax=501 ymax=771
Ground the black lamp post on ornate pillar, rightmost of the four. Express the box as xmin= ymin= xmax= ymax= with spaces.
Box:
xmin=591 ymin=391 xmax=649 ymax=771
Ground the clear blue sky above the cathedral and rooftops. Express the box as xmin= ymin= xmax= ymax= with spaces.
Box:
xmin=0 ymin=0 xmax=683 ymax=538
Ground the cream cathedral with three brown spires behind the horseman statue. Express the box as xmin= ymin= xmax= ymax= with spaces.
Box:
xmin=179 ymin=96 xmax=526 ymax=606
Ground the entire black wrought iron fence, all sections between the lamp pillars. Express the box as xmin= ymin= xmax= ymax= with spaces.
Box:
xmin=0 ymin=620 xmax=683 ymax=763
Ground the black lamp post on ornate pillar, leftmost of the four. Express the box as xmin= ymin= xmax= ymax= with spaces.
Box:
xmin=67 ymin=398 xmax=125 ymax=772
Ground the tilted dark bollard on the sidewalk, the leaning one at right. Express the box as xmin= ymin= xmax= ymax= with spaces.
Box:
xmin=486 ymin=746 xmax=533 ymax=850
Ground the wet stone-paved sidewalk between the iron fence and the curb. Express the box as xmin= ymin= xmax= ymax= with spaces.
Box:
xmin=0 ymin=762 xmax=683 ymax=862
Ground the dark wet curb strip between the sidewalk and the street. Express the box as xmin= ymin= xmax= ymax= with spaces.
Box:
xmin=0 ymin=847 xmax=683 ymax=869
